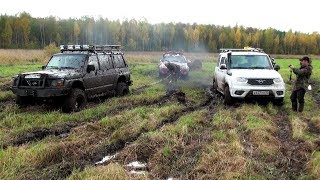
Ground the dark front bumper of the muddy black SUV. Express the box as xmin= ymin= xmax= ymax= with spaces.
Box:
xmin=11 ymin=87 xmax=70 ymax=98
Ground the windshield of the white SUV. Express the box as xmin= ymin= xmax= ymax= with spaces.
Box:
xmin=230 ymin=55 xmax=272 ymax=69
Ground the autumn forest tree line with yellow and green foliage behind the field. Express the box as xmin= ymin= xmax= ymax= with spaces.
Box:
xmin=0 ymin=12 xmax=320 ymax=54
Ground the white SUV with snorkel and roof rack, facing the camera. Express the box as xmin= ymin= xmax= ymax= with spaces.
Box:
xmin=213 ymin=48 xmax=285 ymax=105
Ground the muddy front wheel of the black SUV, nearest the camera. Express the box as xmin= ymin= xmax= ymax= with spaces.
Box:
xmin=62 ymin=88 xmax=87 ymax=113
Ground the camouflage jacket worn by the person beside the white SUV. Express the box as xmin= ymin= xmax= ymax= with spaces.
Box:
xmin=292 ymin=65 xmax=312 ymax=91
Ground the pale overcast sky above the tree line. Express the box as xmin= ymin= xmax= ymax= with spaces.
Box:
xmin=0 ymin=0 xmax=320 ymax=33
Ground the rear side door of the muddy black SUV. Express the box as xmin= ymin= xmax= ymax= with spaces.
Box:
xmin=98 ymin=54 xmax=117 ymax=91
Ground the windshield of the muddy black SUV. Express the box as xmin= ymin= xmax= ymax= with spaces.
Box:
xmin=46 ymin=54 xmax=86 ymax=69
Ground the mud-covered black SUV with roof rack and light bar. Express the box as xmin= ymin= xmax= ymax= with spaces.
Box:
xmin=12 ymin=45 xmax=132 ymax=112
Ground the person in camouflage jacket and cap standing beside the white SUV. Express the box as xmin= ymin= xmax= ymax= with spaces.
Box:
xmin=289 ymin=56 xmax=312 ymax=112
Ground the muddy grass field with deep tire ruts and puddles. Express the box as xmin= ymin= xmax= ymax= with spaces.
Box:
xmin=0 ymin=53 xmax=320 ymax=179
